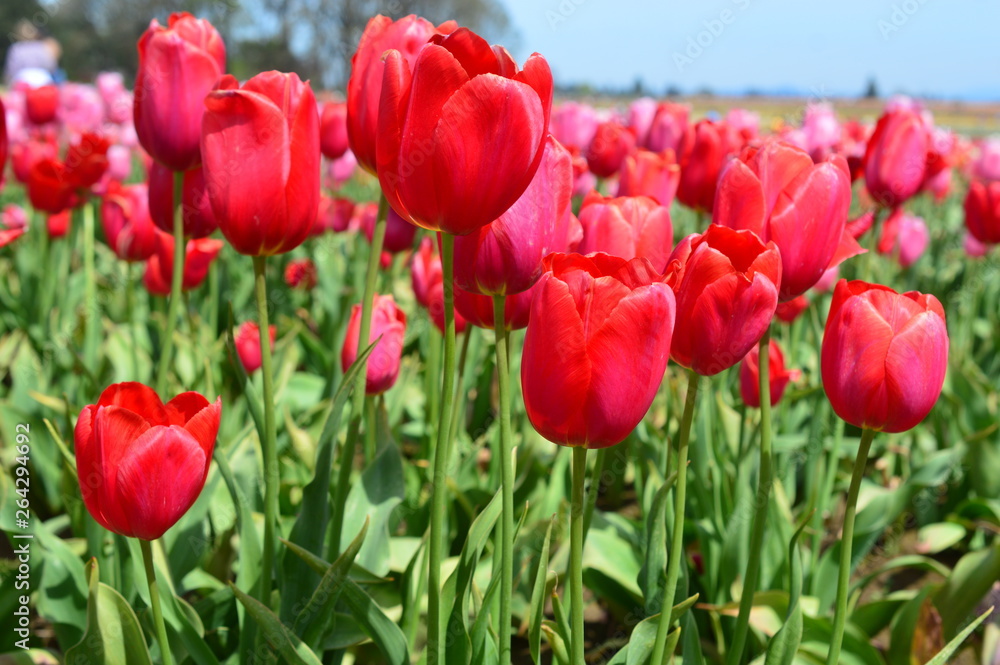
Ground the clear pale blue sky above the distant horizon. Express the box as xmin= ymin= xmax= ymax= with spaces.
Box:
xmin=501 ymin=0 xmax=1000 ymax=101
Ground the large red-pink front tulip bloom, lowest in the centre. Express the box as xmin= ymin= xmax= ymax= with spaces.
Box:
xmin=521 ymin=253 xmax=674 ymax=448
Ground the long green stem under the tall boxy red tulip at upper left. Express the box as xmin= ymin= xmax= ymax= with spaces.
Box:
xmin=253 ymin=256 xmax=280 ymax=616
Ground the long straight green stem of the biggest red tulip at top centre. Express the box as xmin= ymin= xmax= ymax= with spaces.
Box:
xmin=427 ymin=233 xmax=455 ymax=665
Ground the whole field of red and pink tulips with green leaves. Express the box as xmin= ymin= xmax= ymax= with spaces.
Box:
xmin=0 ymin=13 xmax=1000 ymax=665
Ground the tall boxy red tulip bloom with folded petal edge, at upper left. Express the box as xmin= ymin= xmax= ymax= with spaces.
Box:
xmin=201 ymin=72 xmax=320 ymax=256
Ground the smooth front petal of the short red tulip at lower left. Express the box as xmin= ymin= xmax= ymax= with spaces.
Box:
xmin=116 ymin=425 xmax=208 ymax=540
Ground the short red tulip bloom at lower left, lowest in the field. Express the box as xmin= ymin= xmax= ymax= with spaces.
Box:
xmin=74 ymin=383 xmax=222 ymax=540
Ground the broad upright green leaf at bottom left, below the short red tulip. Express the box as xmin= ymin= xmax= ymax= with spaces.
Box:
xmin=66 ymin=559 xmax=153 ymax=665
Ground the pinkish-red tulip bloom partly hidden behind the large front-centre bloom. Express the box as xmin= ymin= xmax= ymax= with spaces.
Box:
xmin=577 ymin=192 xmax=674 ymax=273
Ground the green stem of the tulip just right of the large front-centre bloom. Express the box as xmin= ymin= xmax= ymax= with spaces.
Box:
xmin=649 ymin=370 xmax=701 ymax=665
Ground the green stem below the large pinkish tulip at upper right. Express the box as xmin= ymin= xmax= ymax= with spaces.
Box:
xmin=726 ymin=328 xmax=773 ymax=665
